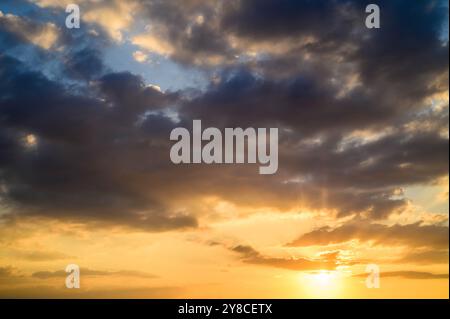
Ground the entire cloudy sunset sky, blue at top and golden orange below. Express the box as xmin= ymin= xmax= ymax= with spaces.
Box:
xmin=0 ymin=0 xmax=449 ymax=298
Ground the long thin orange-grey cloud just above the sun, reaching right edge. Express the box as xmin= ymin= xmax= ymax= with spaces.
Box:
xmin=288 ymin=220 xmax=449 ymax=249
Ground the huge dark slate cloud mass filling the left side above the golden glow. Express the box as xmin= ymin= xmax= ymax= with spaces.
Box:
xmin=0 ymin=56 xmax=197 ymax=231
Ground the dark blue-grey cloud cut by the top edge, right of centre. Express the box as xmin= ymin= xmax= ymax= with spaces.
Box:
xmin=222 ymin=0 xmax=363 ymax=42
